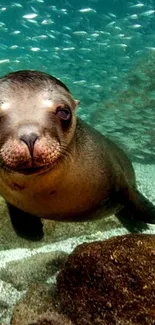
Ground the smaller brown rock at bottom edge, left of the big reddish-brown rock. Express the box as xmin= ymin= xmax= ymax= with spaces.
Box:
xmin=11 ymin=283 xmax=73 ymax=325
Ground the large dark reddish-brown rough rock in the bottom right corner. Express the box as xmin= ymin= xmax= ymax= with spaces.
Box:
xmin=56 ymin=235 xmax=155 ymax=325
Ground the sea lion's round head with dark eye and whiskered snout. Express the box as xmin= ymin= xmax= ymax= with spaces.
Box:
xmin=0 ymin=70 xmax=78 ymax=174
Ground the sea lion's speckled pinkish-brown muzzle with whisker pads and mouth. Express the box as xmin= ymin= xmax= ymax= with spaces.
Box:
xmin=0 ymin=137 xmax=62 ymax=175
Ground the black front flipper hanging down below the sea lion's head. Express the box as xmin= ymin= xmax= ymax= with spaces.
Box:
xmin=7 ymin=203 xmax=44 ymax=240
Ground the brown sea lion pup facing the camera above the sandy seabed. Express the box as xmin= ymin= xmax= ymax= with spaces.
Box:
xmin=0 ymin=70 xmax=155 ymax=239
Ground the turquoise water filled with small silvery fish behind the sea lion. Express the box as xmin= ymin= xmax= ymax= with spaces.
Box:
xmin=0 ymin=0 xmax=155 ymax=164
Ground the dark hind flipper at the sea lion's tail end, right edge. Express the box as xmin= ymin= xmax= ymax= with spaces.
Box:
xmin=118 ymin=187 xmax=155 ymax=224
